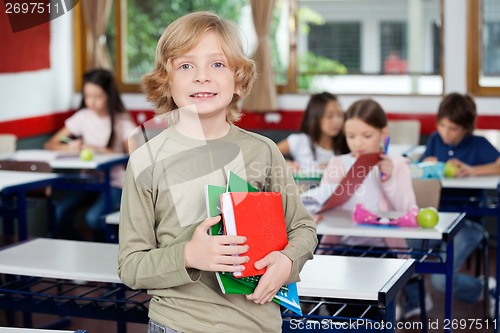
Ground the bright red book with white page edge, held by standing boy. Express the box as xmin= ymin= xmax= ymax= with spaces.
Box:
xmin=221 ymin=192 xmax=288 ymax=277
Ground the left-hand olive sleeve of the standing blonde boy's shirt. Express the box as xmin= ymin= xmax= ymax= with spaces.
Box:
xmin=118 ymin=152 xmax=201 ymax=289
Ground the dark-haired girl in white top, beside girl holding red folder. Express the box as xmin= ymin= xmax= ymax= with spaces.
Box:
xmin=278 ymin=92 xmax=349 ymax=171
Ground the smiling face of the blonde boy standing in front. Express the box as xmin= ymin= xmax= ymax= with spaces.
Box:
xmin=171 ymin=30 xmax=235 ymax=120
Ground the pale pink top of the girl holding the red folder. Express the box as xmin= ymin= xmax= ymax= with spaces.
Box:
xmin=321 ymin=154 xmax=417 ymax=248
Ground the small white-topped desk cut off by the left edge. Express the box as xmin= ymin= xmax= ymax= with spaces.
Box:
xmin=0 ymin=170 xmax=61 ymax=240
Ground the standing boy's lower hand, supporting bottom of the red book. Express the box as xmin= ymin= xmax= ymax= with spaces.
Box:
xmin=246 ymin=251 xmax=292 ymax=304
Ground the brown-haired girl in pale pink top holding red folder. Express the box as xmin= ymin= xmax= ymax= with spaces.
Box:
xmin=321 ymin=99 xmax=416 ymax=248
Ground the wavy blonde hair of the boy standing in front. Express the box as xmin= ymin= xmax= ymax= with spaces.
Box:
xmin=142 ymin=12 xmax=256 ymax=123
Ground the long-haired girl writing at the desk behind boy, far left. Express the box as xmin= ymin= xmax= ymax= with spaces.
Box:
xmin=44 ymin=69 xmax=135 ymax=239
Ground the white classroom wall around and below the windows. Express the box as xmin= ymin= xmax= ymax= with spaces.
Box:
xmin=0 ymin=0 xmax=500 ymax=125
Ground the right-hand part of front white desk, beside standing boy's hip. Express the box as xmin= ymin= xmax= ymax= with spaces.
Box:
xmin=283 ymin=255 xmax=415 ymax=332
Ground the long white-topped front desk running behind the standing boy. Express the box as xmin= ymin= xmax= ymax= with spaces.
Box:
xmin=0 ymin=238 xmax=415 ymax=330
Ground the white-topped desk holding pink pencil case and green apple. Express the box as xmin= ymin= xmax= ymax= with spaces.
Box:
xmin=317 ymin=209 xmax=465 ymax=330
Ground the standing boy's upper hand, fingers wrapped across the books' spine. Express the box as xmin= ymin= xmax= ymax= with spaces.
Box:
xmin=184 ymin=216 xmax=249 ymax=272
